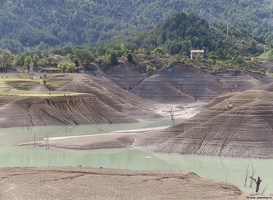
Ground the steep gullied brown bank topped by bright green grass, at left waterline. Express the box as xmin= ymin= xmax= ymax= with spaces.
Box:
xmin=0 ymin=95 xmax=136 ymax=127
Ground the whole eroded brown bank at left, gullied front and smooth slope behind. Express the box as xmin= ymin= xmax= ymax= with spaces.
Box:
xmin=0 ymin=74 xmax=160 ymax=127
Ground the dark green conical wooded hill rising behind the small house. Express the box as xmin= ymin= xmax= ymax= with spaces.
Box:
xmin=95 ymin=12 xmax=258 ymax=56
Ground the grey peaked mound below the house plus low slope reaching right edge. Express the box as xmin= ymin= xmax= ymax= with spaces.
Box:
xmin=129 ymin=63 xmax=272 ymax=103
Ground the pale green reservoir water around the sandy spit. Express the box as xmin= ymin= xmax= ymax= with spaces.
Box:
xmin=0 ymin=120 xmax=273 ymax=194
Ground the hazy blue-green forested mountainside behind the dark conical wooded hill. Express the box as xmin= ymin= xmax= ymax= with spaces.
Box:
xmin=0 ymin=0 xmax=273 ymax=53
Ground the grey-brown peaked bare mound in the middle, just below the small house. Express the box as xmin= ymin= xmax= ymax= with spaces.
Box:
xmin=132 ymin=63 xmax=227 ymax=103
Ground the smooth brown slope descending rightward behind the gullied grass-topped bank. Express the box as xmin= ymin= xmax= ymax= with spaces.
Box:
xmin=56 ymin=74 xmax=160 ymax=120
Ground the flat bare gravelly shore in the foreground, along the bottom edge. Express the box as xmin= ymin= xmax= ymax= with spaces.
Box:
xmin=0 ymin=167 xmax=246 ymax=200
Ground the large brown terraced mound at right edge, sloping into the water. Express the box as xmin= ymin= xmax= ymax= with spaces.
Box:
xmin=136 ymin=91 xmax=273 ymax=158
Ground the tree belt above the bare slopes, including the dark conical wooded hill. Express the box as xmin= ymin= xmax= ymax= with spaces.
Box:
xmin=0 ymin=10 xmax=261 ymax=76
